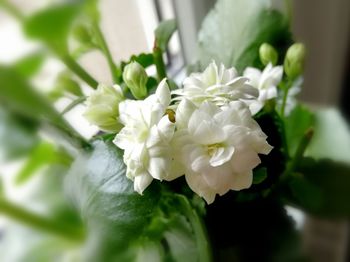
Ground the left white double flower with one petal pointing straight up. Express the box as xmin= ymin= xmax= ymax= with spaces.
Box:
xmin=113 ymin=79 xmax=181 ymax=194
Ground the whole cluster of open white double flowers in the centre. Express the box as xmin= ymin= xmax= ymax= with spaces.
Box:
xmin=84 ymin=62 xmax=283 ymax=203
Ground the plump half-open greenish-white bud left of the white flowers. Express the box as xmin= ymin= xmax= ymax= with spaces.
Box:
xmin=84 ymin=85 xmax=124 ymax=132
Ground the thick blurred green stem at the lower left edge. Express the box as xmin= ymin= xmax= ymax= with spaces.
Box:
xmin=0 ymin=199 xmax=84 ymax=241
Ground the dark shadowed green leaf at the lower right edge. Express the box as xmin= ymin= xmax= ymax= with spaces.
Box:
xmin=285 ymin=158 xmax=350 ymax=217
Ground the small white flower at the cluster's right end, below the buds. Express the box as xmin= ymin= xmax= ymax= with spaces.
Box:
xmin=243 ymin=63 xmax=283 ymax=115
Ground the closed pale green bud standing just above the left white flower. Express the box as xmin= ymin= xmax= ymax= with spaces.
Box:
xmin=123 ymin=62 xmax=148 ymax=99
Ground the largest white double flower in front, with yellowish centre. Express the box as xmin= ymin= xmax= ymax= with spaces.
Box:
xmin=173 ymin=99 xmax=272 ymax=204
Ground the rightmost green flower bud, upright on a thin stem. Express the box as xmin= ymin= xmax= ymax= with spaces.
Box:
xmin=284 ymin=43 xmax=305 ymax=79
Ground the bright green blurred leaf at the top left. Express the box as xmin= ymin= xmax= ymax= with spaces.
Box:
xmin=24 ymin=3 xmax=79 ymax=52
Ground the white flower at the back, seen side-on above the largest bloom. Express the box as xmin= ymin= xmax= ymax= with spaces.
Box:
xmin=173 ymin=62 xmax=259 ymax=106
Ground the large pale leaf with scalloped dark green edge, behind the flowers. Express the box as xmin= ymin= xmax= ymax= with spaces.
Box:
xmin=198 ymin=0 xmax=291 ymax=71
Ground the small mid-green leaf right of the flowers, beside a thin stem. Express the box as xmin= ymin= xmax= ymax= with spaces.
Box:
xmin=284 ymin=104 xmax=315 ymax=156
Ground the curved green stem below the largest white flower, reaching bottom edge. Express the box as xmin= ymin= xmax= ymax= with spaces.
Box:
xmin=179 ymin=195 xmax=212 ymax=262
